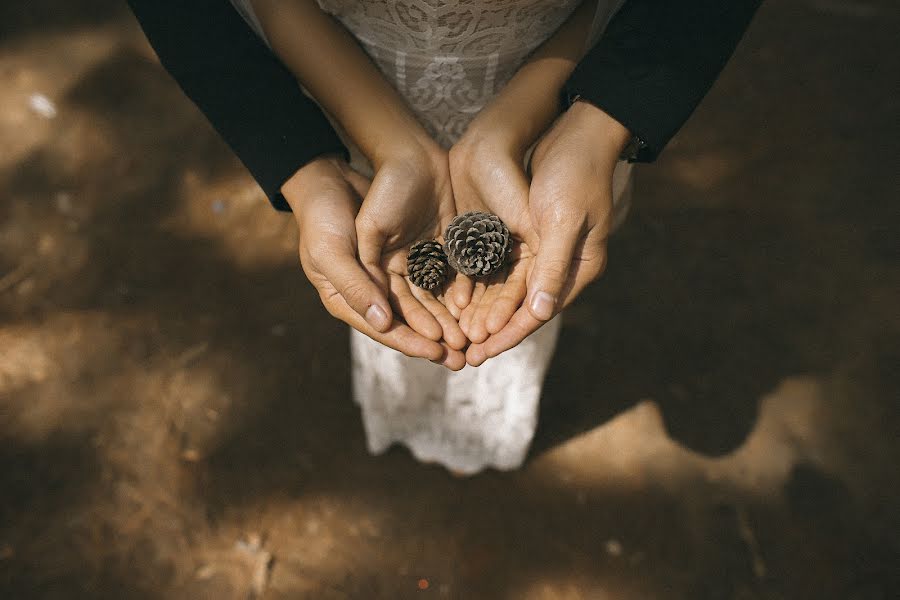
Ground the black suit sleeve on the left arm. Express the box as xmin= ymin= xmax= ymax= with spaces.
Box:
xmin=128 ymin=0 xmax=347 ymax=210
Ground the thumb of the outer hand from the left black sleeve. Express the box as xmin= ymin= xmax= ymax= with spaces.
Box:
xmin=320 ymin=247 xmax=391 ymax=333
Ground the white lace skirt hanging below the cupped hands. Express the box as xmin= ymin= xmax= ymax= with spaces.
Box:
xmin=350 ymin=171 xmax=631 ymax=475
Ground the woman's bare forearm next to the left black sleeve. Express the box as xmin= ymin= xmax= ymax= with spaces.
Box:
xmin=253 ymin=0 xmax=430 ymax=166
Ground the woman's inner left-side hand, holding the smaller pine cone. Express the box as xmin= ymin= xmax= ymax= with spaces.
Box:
xmin=356 ymin=139 xmax=468 ymax=369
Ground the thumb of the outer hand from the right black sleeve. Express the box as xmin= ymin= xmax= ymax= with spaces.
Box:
xmin=528 ymin=229 xmax=578 ymax=321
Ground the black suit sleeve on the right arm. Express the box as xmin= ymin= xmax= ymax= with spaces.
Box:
xmin=564 ymin=0 xmax=761 ymax=162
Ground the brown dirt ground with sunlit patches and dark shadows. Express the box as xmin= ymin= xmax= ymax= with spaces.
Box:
xmin=0 ymin=0 xmax=900 ymax=600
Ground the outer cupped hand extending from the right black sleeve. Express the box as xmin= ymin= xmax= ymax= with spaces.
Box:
xmin=466 ymin=102 xmax=629 ymax=366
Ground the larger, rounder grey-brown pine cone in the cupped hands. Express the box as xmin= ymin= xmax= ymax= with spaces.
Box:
xmin=444 ymin=211 xmax=512 ymax=277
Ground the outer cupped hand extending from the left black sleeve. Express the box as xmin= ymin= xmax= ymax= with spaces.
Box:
xmin=282 ymin=158 xmax=458 ymax=364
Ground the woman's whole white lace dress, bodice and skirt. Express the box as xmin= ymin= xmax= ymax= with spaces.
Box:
xmin=233 ymin=0 xmax=630 ymax=474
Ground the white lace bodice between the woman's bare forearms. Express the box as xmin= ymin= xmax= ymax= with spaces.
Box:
xmin=233 ymin=0 xmax=622 ymax=147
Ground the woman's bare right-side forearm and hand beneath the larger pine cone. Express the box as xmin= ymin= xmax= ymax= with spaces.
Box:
xmin=450 ymin=2 xmax=596 ymax=352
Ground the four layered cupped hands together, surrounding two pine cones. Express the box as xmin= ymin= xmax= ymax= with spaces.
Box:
xmin=282 ymin=102 xmax=628 ymax=370
